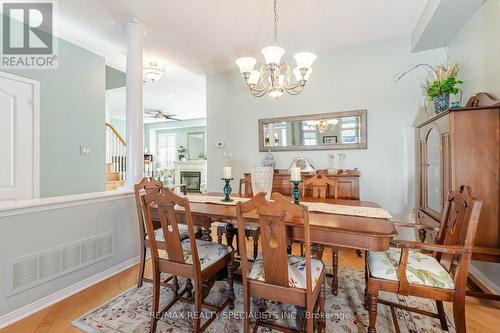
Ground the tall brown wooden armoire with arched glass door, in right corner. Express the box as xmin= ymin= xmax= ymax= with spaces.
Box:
xmin=417 ymin=93 xmax=500 ymax=268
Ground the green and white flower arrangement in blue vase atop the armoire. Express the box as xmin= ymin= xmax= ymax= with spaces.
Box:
xmin=396 ymin=62 xmax=463 ymax=113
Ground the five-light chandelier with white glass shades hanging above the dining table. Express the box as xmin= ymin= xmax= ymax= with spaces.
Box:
xmin=236 ymin=0 xmax=316 ymax=99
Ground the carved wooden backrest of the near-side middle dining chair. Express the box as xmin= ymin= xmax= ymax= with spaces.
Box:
xmin=236 ymin=192 xmax=312 ymax=290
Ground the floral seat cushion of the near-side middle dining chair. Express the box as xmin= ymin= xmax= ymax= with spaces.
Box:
xmin=248 ymin=253 xmax=325 ymax=289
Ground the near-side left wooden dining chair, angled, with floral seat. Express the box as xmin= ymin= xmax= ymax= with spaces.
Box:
xmin=143 ymin=188 xmax=235 ymax=333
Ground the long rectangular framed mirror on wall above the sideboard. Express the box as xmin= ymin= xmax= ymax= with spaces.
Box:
xmin=259 ymin=110 xmax=367 ymax=151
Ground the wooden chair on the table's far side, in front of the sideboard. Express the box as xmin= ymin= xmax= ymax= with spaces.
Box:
xmin=302 ymin=174 xmax=339 ymax=296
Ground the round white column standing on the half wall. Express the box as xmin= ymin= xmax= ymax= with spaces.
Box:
xmin=121 ymin=19 xmax=147 ymax=188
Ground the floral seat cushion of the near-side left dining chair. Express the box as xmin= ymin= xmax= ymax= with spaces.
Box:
xmin=159 ymin=239 xmax=233 ymax=270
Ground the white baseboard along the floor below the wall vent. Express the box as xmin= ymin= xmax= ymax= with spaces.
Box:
xmin=0 ymin=256 xmax=139 ymax=329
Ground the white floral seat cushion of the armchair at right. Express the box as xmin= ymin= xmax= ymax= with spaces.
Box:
xmin=368 ymin=248 xmax=455 ymax=289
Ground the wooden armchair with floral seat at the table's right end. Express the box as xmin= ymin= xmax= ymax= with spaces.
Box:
xmin=365 ymin=186 xmax=482 ymax=333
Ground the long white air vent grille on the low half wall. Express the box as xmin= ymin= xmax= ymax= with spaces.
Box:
xmin=3 ymin=231 xmax=115 ymax=296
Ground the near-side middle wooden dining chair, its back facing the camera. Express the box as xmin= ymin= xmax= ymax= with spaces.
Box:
xmin=236 ymin=193 xmax=325 ymax=333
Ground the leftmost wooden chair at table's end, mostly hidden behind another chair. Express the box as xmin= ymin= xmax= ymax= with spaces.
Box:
xmin=134 ymin=177 xmax=188 ymax=288
